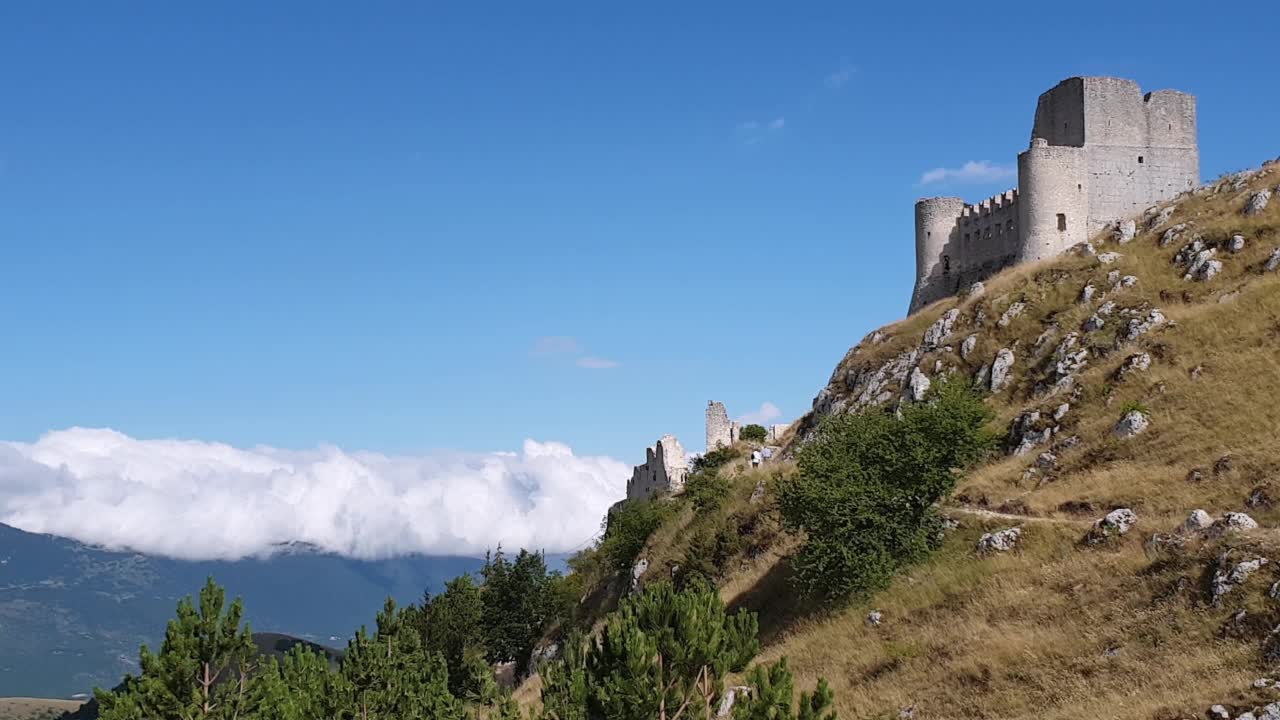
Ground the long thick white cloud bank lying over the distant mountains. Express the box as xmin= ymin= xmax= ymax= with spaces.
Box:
xmin=0 ymin=428 xmax=631 ymax=560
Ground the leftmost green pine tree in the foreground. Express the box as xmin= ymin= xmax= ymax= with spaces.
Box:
xmin=95 ymin=578 xmax=270 ymax=720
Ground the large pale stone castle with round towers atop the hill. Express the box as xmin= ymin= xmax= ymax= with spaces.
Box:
xmin=911 ymin=77 xmax=1199 ymax=311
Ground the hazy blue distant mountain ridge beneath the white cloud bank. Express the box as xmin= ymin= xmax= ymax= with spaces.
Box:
xmin=0 ymin=524 xmax=484 ymax=697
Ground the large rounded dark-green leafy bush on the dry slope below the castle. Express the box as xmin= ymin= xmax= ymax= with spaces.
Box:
xmin=778 ymin=379 xmax=995 ymax=601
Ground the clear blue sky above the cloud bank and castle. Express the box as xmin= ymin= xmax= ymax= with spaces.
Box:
xmin=0 ymin=1 xmax=1280 ymax=462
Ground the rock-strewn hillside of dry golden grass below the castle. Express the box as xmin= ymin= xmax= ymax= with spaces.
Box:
xmin=537 ymin=164 xmax=1280 ymax=719
